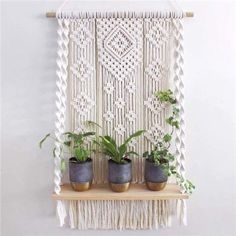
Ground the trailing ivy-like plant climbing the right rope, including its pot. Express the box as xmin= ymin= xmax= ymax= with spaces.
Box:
xmin=143 ymin=90 xmax=195 ymax=193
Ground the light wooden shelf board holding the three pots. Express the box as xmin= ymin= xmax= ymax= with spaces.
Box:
xmin=52 ymin=184 xmax=189 ymax=200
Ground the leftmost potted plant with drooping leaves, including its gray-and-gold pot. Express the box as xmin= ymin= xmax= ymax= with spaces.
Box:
xmin=39 ymin=123 xmax=98 ymax=191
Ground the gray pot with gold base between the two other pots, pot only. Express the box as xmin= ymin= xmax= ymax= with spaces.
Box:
xmin=108 ymin=159 xmax=132 ymax=192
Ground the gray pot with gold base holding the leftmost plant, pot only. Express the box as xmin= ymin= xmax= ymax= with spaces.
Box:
xmin=69 ymin=157 xmax=93 ymax=191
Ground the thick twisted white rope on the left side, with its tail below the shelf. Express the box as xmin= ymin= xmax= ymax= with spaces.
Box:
xmin=54 ymin=15 xmax=69 ymax=226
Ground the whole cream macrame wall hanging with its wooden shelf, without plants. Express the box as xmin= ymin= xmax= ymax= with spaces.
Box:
xmin=49 ymin=8 xmax=192 ymax=230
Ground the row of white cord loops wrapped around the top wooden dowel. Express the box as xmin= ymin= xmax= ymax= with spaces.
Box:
xmin=57 ymin=11 xmax=184 ymax=19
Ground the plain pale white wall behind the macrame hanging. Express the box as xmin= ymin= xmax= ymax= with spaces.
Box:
xmin=1 ymin=1 xmax=236 ymax=236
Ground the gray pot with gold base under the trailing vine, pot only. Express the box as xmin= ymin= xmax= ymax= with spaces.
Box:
xmin=145 ymin=159 xmax=168 ymax=191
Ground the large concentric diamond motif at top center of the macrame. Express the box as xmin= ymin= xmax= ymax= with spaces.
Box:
xmin=104 ymin=26 xmax=134 ymax=60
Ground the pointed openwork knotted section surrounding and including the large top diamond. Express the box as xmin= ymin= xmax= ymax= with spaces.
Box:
xmin=97 ymin=18 xmax=143 ymax=82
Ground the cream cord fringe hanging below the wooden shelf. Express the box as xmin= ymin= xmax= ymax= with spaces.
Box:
xmin=65 ymin=200 xmax=176 ymax=230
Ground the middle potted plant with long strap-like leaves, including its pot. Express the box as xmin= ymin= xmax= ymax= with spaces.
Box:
xmin=98 ymin=130 xmax=144 ymax=192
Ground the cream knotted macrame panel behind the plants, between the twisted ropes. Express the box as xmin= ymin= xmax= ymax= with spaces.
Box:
xmin=68 ymin=18 xmax=173 ymax=183
